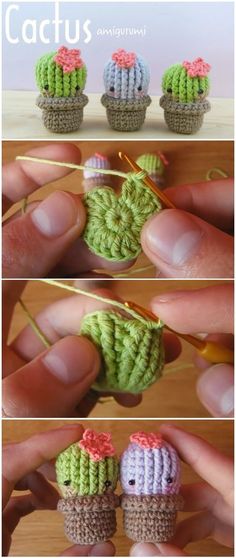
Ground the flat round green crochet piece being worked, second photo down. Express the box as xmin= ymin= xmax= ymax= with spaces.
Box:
xmin=83 ymin=173 xmax=161 ymax=262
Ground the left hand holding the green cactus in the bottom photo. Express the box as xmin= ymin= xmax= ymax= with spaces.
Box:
xmin=2 ymin=424 xmax=115 ymax=556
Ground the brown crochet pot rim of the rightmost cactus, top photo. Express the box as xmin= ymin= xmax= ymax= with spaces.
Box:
xmin=160 ymin=94 xmax=211 ymax=116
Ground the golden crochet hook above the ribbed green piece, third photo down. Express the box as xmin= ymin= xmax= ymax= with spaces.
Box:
xmin=125 ymin=301 xmax=234 ymax=364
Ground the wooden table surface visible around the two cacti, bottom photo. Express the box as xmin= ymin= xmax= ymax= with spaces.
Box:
xmin=3 ymin=420 xmax=233 ymax=556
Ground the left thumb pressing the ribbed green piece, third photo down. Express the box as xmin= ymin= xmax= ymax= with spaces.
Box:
xmin=2 ymin=336 xmax=100 ymax=417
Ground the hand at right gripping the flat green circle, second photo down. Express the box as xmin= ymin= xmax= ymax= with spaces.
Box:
xmin=141 ymin=178 xmax=234 ymax=278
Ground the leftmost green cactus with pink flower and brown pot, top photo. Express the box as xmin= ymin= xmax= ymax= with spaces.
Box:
xmin=35 ymin=47 xmax=88 ymax=133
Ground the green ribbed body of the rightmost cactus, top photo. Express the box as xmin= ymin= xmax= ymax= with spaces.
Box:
xmin=162 ymin=64 xmax=210 ymax=103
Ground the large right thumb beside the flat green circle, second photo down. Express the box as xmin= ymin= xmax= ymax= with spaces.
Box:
xmin=141 ymin=209 xmax=233 ymax=278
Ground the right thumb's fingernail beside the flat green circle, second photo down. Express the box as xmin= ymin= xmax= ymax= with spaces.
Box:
xmin=145 ymin=209 xmax=204 ymax=266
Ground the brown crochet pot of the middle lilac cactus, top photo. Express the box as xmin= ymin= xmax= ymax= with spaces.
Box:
xmin=101 ymin=94 xmax=152 ymax=132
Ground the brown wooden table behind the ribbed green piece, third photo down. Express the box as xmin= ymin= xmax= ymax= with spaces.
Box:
xmin=6 ymin=280 xmax=230 ymax=418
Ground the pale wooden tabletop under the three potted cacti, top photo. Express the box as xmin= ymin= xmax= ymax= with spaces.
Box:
xmin=2 ymin=91 xmax=234 ymax=140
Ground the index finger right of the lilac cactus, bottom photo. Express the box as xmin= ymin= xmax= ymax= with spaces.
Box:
xmin=160 ymin=424 xmax=234 ymax=504
